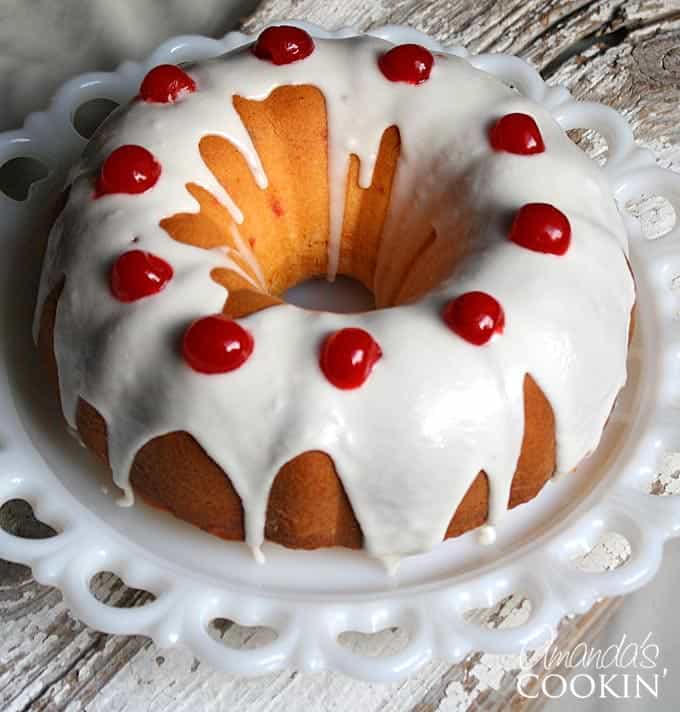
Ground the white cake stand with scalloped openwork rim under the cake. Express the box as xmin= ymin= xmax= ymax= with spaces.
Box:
xmin=0 ymin=23 xmax=680 ymax=681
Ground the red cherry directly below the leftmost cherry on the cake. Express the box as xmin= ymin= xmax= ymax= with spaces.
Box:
xmin=109 ymin=250 xmax=173 ymax=302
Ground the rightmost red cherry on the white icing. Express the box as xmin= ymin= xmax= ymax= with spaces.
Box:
xmin=509 ymin=203 xmax=571 ymax=255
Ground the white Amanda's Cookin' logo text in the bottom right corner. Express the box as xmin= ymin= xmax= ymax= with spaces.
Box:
xmin=517 ymin=633 xmax=668 ymax=700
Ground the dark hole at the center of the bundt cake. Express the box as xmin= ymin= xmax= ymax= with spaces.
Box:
xmin=283 ymin=275 xmax=375 ymax=314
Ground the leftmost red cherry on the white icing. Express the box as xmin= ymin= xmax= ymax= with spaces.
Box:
xmin=96 ymin=146 xmax=161 ymax=197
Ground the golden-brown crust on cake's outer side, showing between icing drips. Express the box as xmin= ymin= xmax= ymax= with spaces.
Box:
xmin=38 ymin=280 xmax=555 ymax=549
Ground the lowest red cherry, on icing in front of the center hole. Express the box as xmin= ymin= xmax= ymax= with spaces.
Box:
xmin=320 ymin=328 xmax=382 ymax=390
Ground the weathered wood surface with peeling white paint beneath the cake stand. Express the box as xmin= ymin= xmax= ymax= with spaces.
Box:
xmin=0 ymin=0 xmax=680 ymax=712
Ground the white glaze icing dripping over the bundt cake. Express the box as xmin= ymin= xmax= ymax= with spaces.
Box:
xmin=36 ymin=37 xmax=634 ymax=561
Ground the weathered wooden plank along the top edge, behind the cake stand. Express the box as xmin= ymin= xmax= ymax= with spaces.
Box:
xmin=244 ymin=0 xmax=680 ymax=68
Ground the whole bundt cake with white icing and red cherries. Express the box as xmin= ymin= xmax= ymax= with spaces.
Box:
xmin=35 ymin=26 xmax=635 ymax=559
